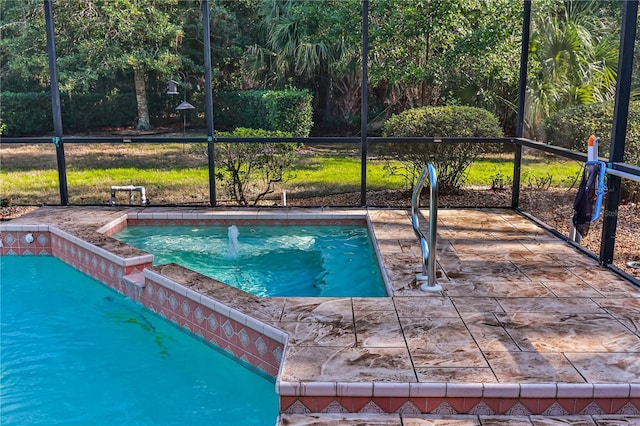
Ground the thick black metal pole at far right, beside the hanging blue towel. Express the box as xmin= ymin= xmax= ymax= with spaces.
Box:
xmin=600 ymin=0 xmax=638 ymax=265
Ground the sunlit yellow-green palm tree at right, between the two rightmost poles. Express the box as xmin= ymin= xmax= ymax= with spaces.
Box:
xmin=525 ymin=1 xmax=618 ymax=137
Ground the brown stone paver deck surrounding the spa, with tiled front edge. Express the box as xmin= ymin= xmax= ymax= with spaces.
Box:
xmin=0 ymin=207 xmax=640 ymax=425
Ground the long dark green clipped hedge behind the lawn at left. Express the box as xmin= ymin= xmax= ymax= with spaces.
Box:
xmin=0 ymin=90 xmax=313 ymax=137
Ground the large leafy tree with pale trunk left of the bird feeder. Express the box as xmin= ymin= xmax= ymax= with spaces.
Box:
xmin=2 ymin=0 xmax=184 ymax=129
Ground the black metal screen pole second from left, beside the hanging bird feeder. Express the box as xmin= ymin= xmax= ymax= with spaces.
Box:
xmin=202 ymin=0 xmax=216 ymax=206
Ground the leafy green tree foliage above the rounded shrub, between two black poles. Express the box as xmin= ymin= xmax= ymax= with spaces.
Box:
xmin=370 ymin=0 xmax=522 ymax=120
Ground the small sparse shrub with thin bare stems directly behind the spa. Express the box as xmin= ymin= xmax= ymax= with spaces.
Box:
xmin=215 ymin=128 xmax=296 ymax=206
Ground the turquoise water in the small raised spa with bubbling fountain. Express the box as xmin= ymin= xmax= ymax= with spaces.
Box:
xmin=115 ymin=226 xmax=386 ymax=297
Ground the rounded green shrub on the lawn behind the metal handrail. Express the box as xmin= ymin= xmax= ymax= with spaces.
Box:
xmin=383 ymin=106 xmax=503 ymax=192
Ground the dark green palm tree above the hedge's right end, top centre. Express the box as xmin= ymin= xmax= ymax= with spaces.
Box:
xmin=245 ymin=0 xmax=361 ymax=126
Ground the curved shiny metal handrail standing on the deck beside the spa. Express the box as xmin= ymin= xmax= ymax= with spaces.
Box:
xmin=411 ymin=163 xmax=442 ymax=292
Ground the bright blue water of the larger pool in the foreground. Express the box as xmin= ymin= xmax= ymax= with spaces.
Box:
xmin=0 ymin=256 xmax=278 ymax=425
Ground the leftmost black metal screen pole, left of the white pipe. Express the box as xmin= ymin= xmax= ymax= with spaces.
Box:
xmin=44 ymin=0 xmax=69 ymax=206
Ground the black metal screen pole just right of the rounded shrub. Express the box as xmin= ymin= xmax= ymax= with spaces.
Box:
xmin=511 ymin=0 xmax=531 ymax=209
